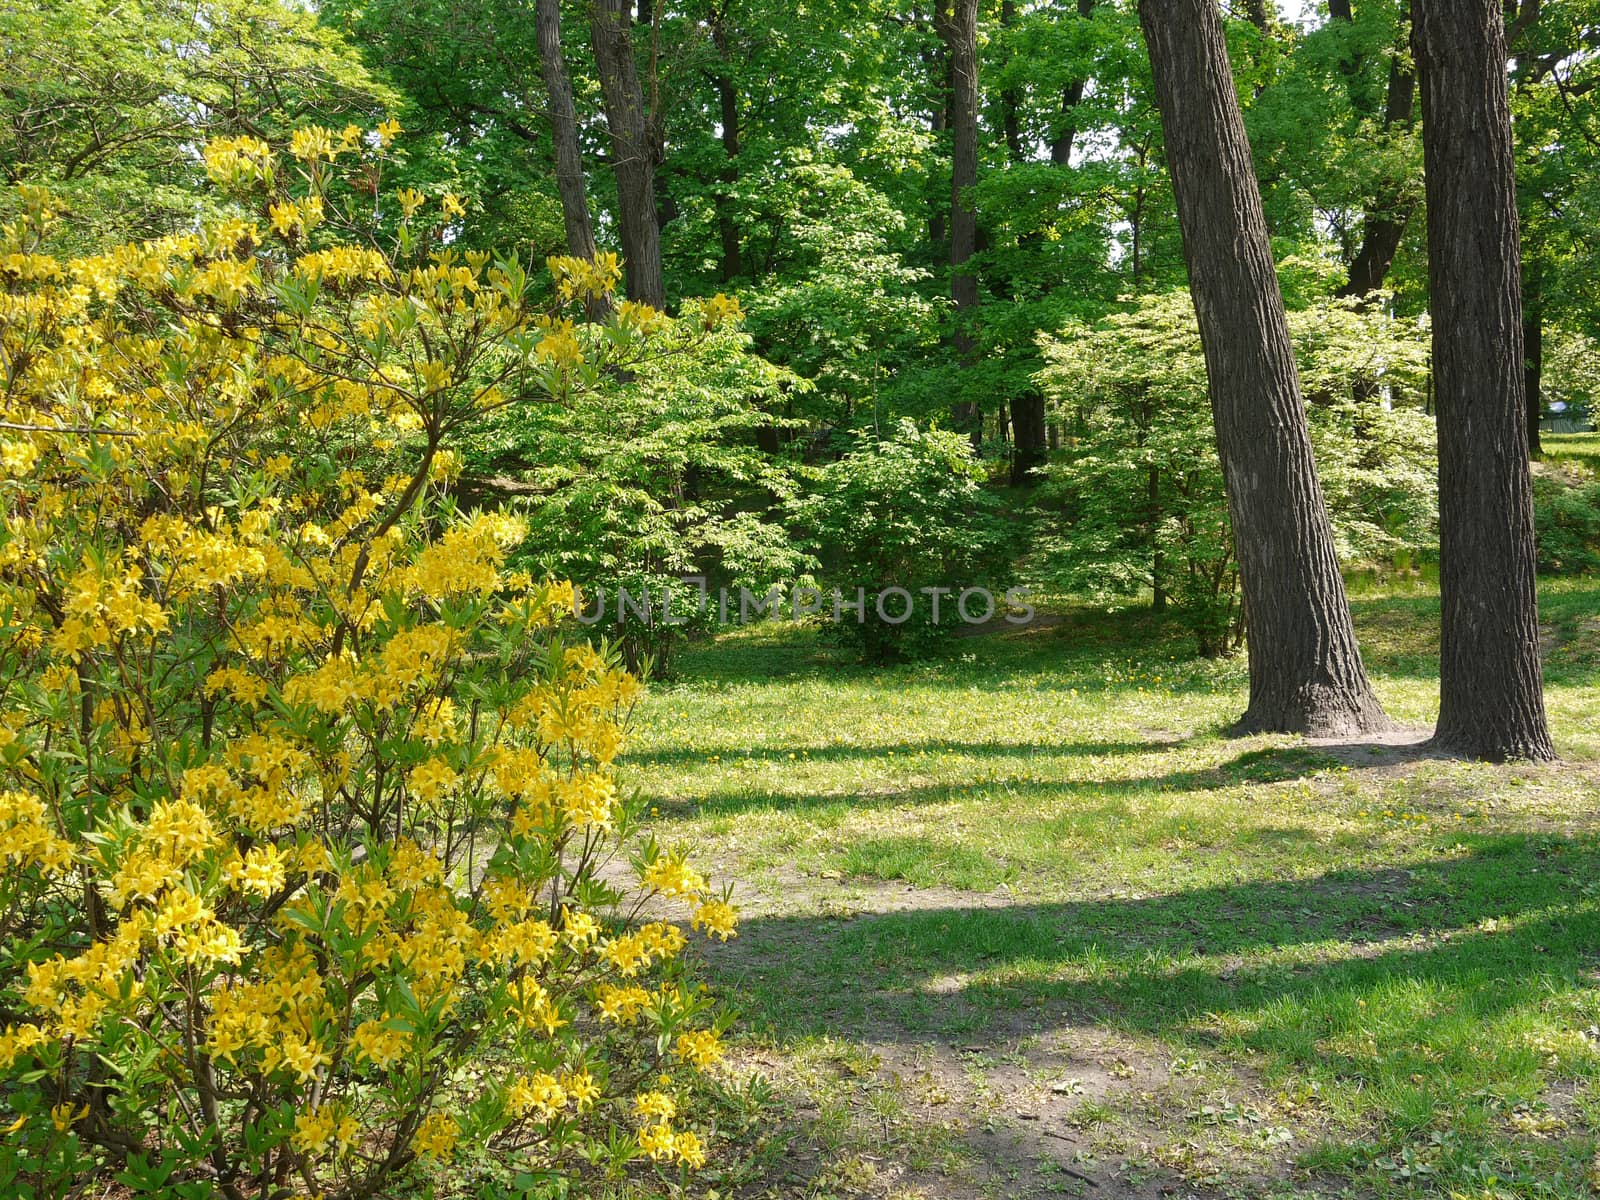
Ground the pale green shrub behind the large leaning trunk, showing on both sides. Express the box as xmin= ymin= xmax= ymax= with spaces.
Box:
xmin=1035 ymin=293 xmax=1438 ymax=654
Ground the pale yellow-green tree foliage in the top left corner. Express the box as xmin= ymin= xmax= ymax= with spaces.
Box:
xmin=0 ymin=0 xmax=387 ymax=245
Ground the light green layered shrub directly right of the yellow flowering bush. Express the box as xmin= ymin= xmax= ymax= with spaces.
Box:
xmin=474 ymin=316 xmax=808 ymax=675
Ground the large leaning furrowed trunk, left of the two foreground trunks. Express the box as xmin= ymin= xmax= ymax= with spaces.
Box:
xmin=1139 ymin=0 xmax=1389 ymax=736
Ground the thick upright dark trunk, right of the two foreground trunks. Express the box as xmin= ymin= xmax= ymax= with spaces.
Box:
xmin=1411 ymin=0 xmax=1555 ymax=762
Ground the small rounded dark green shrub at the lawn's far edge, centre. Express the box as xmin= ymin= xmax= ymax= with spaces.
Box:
xmin=790 ymin=421 xmax=1013 ymax=661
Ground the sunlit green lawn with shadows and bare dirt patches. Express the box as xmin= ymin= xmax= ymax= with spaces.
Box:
xmin=629 ymin=581 xmax=1600 ymax=1200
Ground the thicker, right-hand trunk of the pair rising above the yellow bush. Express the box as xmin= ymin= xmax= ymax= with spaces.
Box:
xmin=589 ymin=0 xmax=667 ymax=309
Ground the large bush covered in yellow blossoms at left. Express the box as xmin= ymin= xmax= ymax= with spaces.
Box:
xmin=0 ymin=131 xmax=736 ymax=1200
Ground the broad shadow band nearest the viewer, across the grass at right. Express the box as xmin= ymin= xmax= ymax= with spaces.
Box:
xmin=714 ymin=835 xmax=1600 ymax=1050
